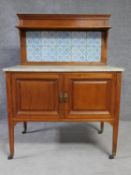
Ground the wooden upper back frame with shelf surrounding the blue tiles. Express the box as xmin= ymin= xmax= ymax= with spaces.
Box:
xmin=17 ymin=14 xmax=111 ymax=65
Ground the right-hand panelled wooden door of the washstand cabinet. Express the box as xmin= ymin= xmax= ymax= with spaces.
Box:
xmin=64 ymin=73 xmax=115 ymax=119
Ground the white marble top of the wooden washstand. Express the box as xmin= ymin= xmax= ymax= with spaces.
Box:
xmin=3 ymin=65 xmax=124 ymax=72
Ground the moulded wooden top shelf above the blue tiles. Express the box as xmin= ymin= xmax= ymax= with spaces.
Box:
xmin=17 ymin=14 xmax=111 ymax=30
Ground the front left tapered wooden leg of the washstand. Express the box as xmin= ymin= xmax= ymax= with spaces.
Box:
xmin=8 ymin=122 xmax=14 ymax=159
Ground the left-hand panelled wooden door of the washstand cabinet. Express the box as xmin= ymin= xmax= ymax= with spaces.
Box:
xmin=12 ymin=73 xmax=62 ymax=120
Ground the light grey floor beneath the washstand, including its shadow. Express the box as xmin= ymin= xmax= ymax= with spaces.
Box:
xmin=0 ymin=120 xmax=131 ymax=175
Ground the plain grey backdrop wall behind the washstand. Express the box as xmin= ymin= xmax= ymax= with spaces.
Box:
xmin=0 ymin=0 xmax=131 ymax=120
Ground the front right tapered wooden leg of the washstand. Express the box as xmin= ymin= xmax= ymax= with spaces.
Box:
xmin=109 ymin=121 xmax=118 ymax=159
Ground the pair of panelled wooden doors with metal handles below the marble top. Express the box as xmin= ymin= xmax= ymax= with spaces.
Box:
xmin=12 ymin=73 xmax=115 ymax=120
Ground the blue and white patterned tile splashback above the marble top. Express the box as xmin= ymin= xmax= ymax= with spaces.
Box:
xmin=26 ymin=31 xmax=101 ymax=62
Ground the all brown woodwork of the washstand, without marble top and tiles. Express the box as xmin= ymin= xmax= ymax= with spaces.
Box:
xmin=3 ymin=14 xmax=122 ymax=159
